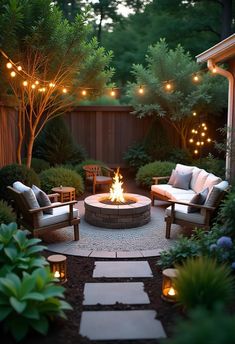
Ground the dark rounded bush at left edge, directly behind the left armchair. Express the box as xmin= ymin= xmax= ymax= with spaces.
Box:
xmin=0 ymin=164 xmax=40 ymax=201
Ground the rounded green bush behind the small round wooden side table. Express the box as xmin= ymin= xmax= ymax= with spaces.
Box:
xmin=39 ymin=167 xmax=84 ymax=195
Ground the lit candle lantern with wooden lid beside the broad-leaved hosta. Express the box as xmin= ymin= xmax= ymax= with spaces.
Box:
xmin=47 ymin=254 xmax=67 ymax=283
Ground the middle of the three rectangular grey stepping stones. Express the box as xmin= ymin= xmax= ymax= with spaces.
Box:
xmin=83 ymin=282 xmax=150 ymax=305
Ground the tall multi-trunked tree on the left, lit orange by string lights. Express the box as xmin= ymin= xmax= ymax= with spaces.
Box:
xmin=0 ymin=0 xmax=113 ymax=167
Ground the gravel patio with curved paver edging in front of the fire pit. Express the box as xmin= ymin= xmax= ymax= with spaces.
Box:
xmin=43 ymin=201 xmax=181 ymax=258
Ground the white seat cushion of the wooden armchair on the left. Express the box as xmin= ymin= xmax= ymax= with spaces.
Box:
xmin=39 ymin=203 xmax=79 ymax=227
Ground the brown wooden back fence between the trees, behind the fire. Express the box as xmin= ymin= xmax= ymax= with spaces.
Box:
xmin=66 ymin=106 xmax=154 ymax=167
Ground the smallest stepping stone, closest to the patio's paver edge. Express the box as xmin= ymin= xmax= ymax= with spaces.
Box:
xmin=93 ymin=261 xmax=153 ymax=278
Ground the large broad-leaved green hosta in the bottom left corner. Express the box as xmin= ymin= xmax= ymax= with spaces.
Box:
xmin=0 ymin=268 xmax=71 ymax=341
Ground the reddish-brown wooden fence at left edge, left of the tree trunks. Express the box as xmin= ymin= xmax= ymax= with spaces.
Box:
xmin=0 ymin=104 xmax=17 ymax=167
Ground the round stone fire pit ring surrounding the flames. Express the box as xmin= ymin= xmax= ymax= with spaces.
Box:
xmin=84 ymin=193 xmax=151 ymax=229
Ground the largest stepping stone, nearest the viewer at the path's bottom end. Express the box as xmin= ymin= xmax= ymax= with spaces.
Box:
xmin=79 ymin=310 xmax=166 ymax=340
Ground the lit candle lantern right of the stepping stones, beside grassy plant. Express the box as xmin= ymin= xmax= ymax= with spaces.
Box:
xmin=161 ymin=269 xmax=178 ymax=302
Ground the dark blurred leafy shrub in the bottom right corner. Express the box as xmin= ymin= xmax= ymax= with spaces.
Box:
xmin=161 ymin=307 xmax=235 ymax=344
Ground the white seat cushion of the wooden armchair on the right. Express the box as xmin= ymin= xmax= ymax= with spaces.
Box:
xmin=165 ymin=204 xmax=205 ymax=225
